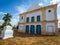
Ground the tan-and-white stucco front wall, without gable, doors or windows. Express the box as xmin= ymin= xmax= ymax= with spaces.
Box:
xmin=19 ymin=5 xmax=58 ymax=35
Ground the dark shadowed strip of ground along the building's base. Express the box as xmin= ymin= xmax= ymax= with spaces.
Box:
xmin=14 ymin=30 xmax=58 ymax=37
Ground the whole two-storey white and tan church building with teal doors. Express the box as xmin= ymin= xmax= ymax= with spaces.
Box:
xmin=18 ymin=4 xmax=58 ymax=35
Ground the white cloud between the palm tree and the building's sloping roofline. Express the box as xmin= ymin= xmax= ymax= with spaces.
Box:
xmin=10 ymin=4 xmax=29 ymax=26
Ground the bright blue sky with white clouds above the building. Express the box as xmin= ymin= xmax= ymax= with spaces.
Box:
xmin=0 ymin=0 xmax=60 ymax=26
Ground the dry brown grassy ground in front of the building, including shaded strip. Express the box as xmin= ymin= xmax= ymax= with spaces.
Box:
xmin=0 ymin=31 xmax=60 ymax=45
